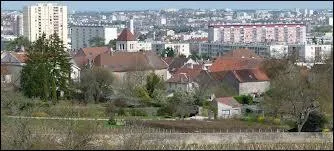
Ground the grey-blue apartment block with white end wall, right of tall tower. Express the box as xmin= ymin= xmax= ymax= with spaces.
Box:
xmin=70 ymin=26 xmax=117 ymax=50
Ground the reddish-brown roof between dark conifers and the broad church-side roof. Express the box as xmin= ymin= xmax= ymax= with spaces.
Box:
xmin=73 ymin=47 xmax=112 ymax=68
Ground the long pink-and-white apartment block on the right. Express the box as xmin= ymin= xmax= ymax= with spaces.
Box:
xmin=208 ymin=24 xmax=306 ymax=44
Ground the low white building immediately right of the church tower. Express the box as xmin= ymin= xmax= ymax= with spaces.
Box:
xmin=152 ymin=43 xmax=191 ymax=57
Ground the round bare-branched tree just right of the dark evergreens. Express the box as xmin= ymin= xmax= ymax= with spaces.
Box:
xmin=79 ymin=67 xmax=114 ymax=102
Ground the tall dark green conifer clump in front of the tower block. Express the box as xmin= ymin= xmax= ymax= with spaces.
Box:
xmin=21 ymin=33 xmax=71 ymax=101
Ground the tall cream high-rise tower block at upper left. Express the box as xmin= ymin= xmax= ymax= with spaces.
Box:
xmin=23 ymin=3 xmax=68 ymax=46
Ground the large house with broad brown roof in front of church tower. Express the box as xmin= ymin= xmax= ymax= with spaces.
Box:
xmin=94 ymin=51 xmax=171 ymax=82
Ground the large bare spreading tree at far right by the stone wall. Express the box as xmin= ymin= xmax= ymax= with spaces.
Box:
xmin=263 ymin=56 xmax=328 ymax=132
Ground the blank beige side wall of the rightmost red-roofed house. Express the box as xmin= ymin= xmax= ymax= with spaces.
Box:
xmin=239 ymin=81 xmax=270 ymax=95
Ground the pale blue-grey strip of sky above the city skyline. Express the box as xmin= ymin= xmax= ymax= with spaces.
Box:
xmin=1 ymin=1 xmax=333 ymax=11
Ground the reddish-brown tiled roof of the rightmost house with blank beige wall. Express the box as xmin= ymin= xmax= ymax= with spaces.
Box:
xmin=230 ymin=68 xmax=269 ymax=82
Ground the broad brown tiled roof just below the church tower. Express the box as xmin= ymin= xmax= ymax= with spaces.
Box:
xmin=94 ymin=52 xmax=168 ymax=72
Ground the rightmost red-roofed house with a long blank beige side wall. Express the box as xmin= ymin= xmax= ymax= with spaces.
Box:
xmin=223 ymin=68 xmax=270 ymax=95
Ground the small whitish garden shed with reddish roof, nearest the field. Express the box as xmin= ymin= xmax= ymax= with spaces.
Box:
xmin=213 ymin=97 xmax=242 ymax=118
